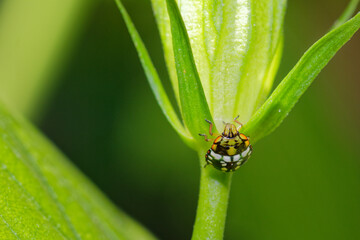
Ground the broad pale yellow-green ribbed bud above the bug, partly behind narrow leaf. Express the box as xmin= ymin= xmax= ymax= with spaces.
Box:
xmin=152 ymin=0 xmax=286 ymax=126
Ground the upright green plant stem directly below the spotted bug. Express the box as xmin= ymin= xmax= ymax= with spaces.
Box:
xmin=192 ymin=151 xmax=232 ymax=240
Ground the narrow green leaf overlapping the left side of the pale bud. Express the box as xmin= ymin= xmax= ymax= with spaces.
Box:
xmin=167 ymin=0 xmax=213 ymax=139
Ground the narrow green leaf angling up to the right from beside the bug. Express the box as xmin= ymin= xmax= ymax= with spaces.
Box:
xmin=242 ymin=13 xmax=360 ymax=142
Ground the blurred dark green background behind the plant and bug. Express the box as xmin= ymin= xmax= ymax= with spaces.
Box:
xmin=0 ymin=0 xmax=360 ymax=240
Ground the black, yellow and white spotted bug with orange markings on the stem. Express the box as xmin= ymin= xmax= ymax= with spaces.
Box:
xmin=199 ymin=116 xmax=253 ymax=172
